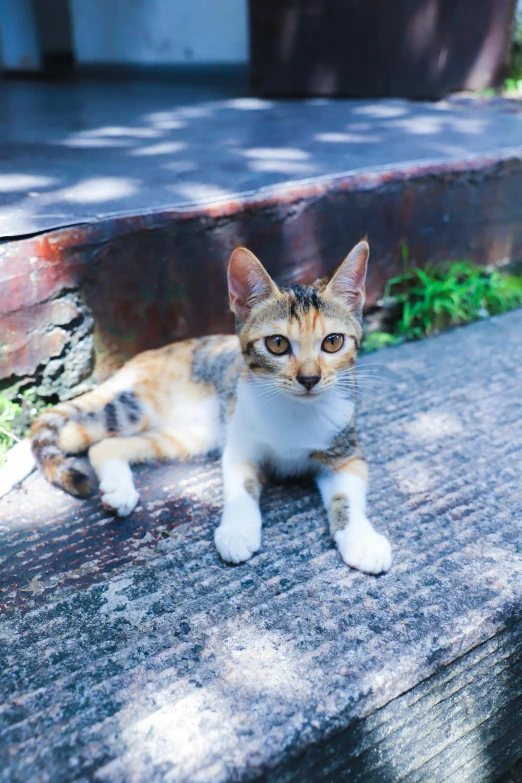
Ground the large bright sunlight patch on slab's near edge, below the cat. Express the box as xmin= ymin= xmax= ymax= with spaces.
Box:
xmin=102 ymin=615 xmax=314 ymax=781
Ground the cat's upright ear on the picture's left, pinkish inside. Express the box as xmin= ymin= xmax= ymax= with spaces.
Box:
xmin=228 ymin=247 xmax=278 ymax=321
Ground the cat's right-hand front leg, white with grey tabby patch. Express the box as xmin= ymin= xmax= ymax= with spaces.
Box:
xmin=317 ymin=458 xmax=392 ymax=574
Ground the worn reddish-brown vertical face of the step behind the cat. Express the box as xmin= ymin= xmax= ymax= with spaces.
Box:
xmin=0 ymin=147 xmax=522 ymax=397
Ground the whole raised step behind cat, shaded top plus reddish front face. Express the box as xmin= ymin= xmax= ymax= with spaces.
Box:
xmin=0 ymin=79 xmax=522 ymax=396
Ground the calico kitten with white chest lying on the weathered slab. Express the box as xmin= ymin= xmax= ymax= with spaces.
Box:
xmin=25 ymin=241 xmax=391 ymax=574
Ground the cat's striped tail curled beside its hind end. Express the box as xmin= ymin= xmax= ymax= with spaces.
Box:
xmin=31 ymin=403 xmax=96 ymax=498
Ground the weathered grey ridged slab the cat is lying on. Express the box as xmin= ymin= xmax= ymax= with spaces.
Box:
xmin=0 ymin=311 xmax=522 ymax=783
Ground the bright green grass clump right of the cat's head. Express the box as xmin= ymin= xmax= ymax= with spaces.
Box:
xmin=364 ymin=261 xmax=522 ymax=352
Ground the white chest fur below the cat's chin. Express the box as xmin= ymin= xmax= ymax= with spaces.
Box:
xmin=227 ymin=380 xmax=353 ymax=475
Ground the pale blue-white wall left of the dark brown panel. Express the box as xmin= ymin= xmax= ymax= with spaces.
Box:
xmin=70 ymin=0 xmax=248 ymax=65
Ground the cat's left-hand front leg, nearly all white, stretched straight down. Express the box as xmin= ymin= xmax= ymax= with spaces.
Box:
xmin=214 ymin=446 xmax=261 ymax=563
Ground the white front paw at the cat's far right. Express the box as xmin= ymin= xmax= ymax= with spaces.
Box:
xmin=335 ymin=522 xmax=392 ymax=574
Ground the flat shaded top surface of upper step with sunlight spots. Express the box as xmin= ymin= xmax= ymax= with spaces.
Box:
xmin=0 ymin=77 xmax=522 ymax=237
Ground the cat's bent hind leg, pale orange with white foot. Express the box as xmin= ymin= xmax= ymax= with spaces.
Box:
xmin=89 ymin=427 xmax=214 ymax=517
